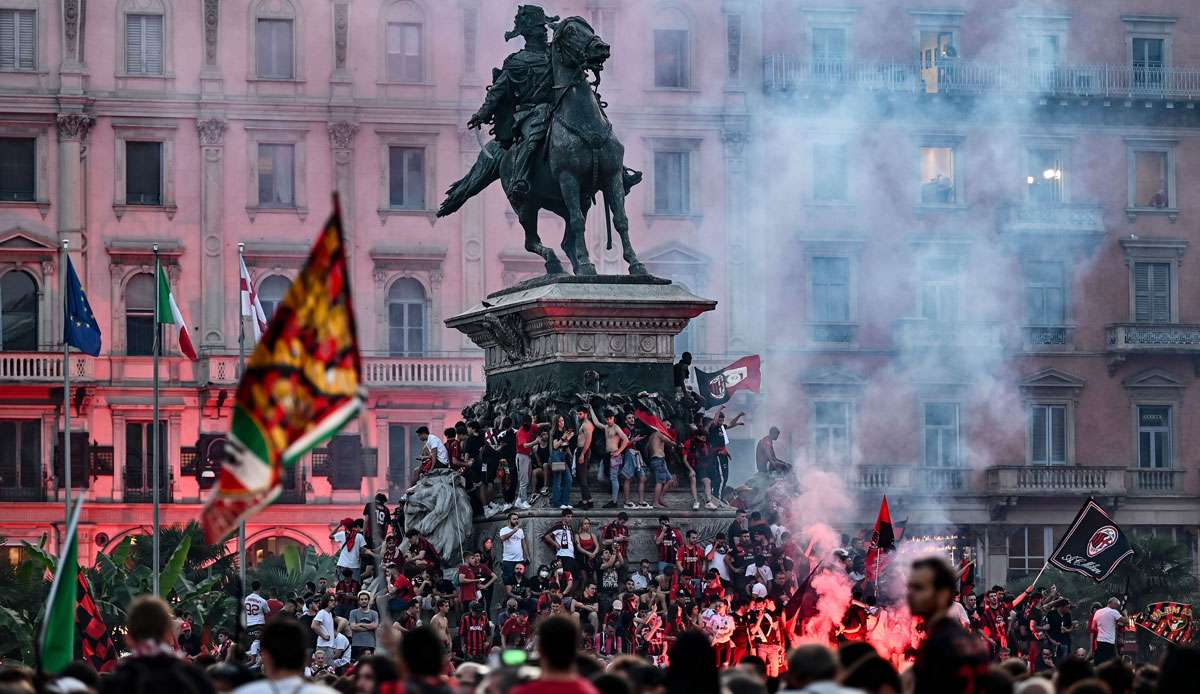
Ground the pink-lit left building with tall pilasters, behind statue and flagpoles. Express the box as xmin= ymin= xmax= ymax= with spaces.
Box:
xmin=0 ymin=0 xmax=761 ymax=561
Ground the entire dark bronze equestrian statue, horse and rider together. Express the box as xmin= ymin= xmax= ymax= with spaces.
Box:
xmin=438 ymin=5 xmax=646 ymax=275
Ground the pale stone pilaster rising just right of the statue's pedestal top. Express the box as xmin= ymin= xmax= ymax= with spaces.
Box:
xmin=721 ymin=125 xmax=754 ymax=353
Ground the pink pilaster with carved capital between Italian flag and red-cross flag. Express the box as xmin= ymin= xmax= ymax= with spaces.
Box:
xmin=196 ymin=118 xmax=226 ymax=348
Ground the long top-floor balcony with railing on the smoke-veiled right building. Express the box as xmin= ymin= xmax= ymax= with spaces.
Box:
xmin=763 ymin=54 xmax=1200 ymax=101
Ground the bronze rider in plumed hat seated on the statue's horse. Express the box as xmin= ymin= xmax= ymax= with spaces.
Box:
xmin=467 ymin=5 xmax=558 ymax=205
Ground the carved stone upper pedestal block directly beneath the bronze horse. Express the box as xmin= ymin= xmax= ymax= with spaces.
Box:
xmin=446 ymin=275 xmax=716 ymax=396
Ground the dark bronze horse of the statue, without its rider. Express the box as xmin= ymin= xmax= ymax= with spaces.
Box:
xmin=437 ymin=17 xmax=647 ymax=275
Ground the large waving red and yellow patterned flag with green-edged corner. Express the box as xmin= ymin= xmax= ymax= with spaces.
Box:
xmin=202 ymin=197 xmax=365 ymax=543
